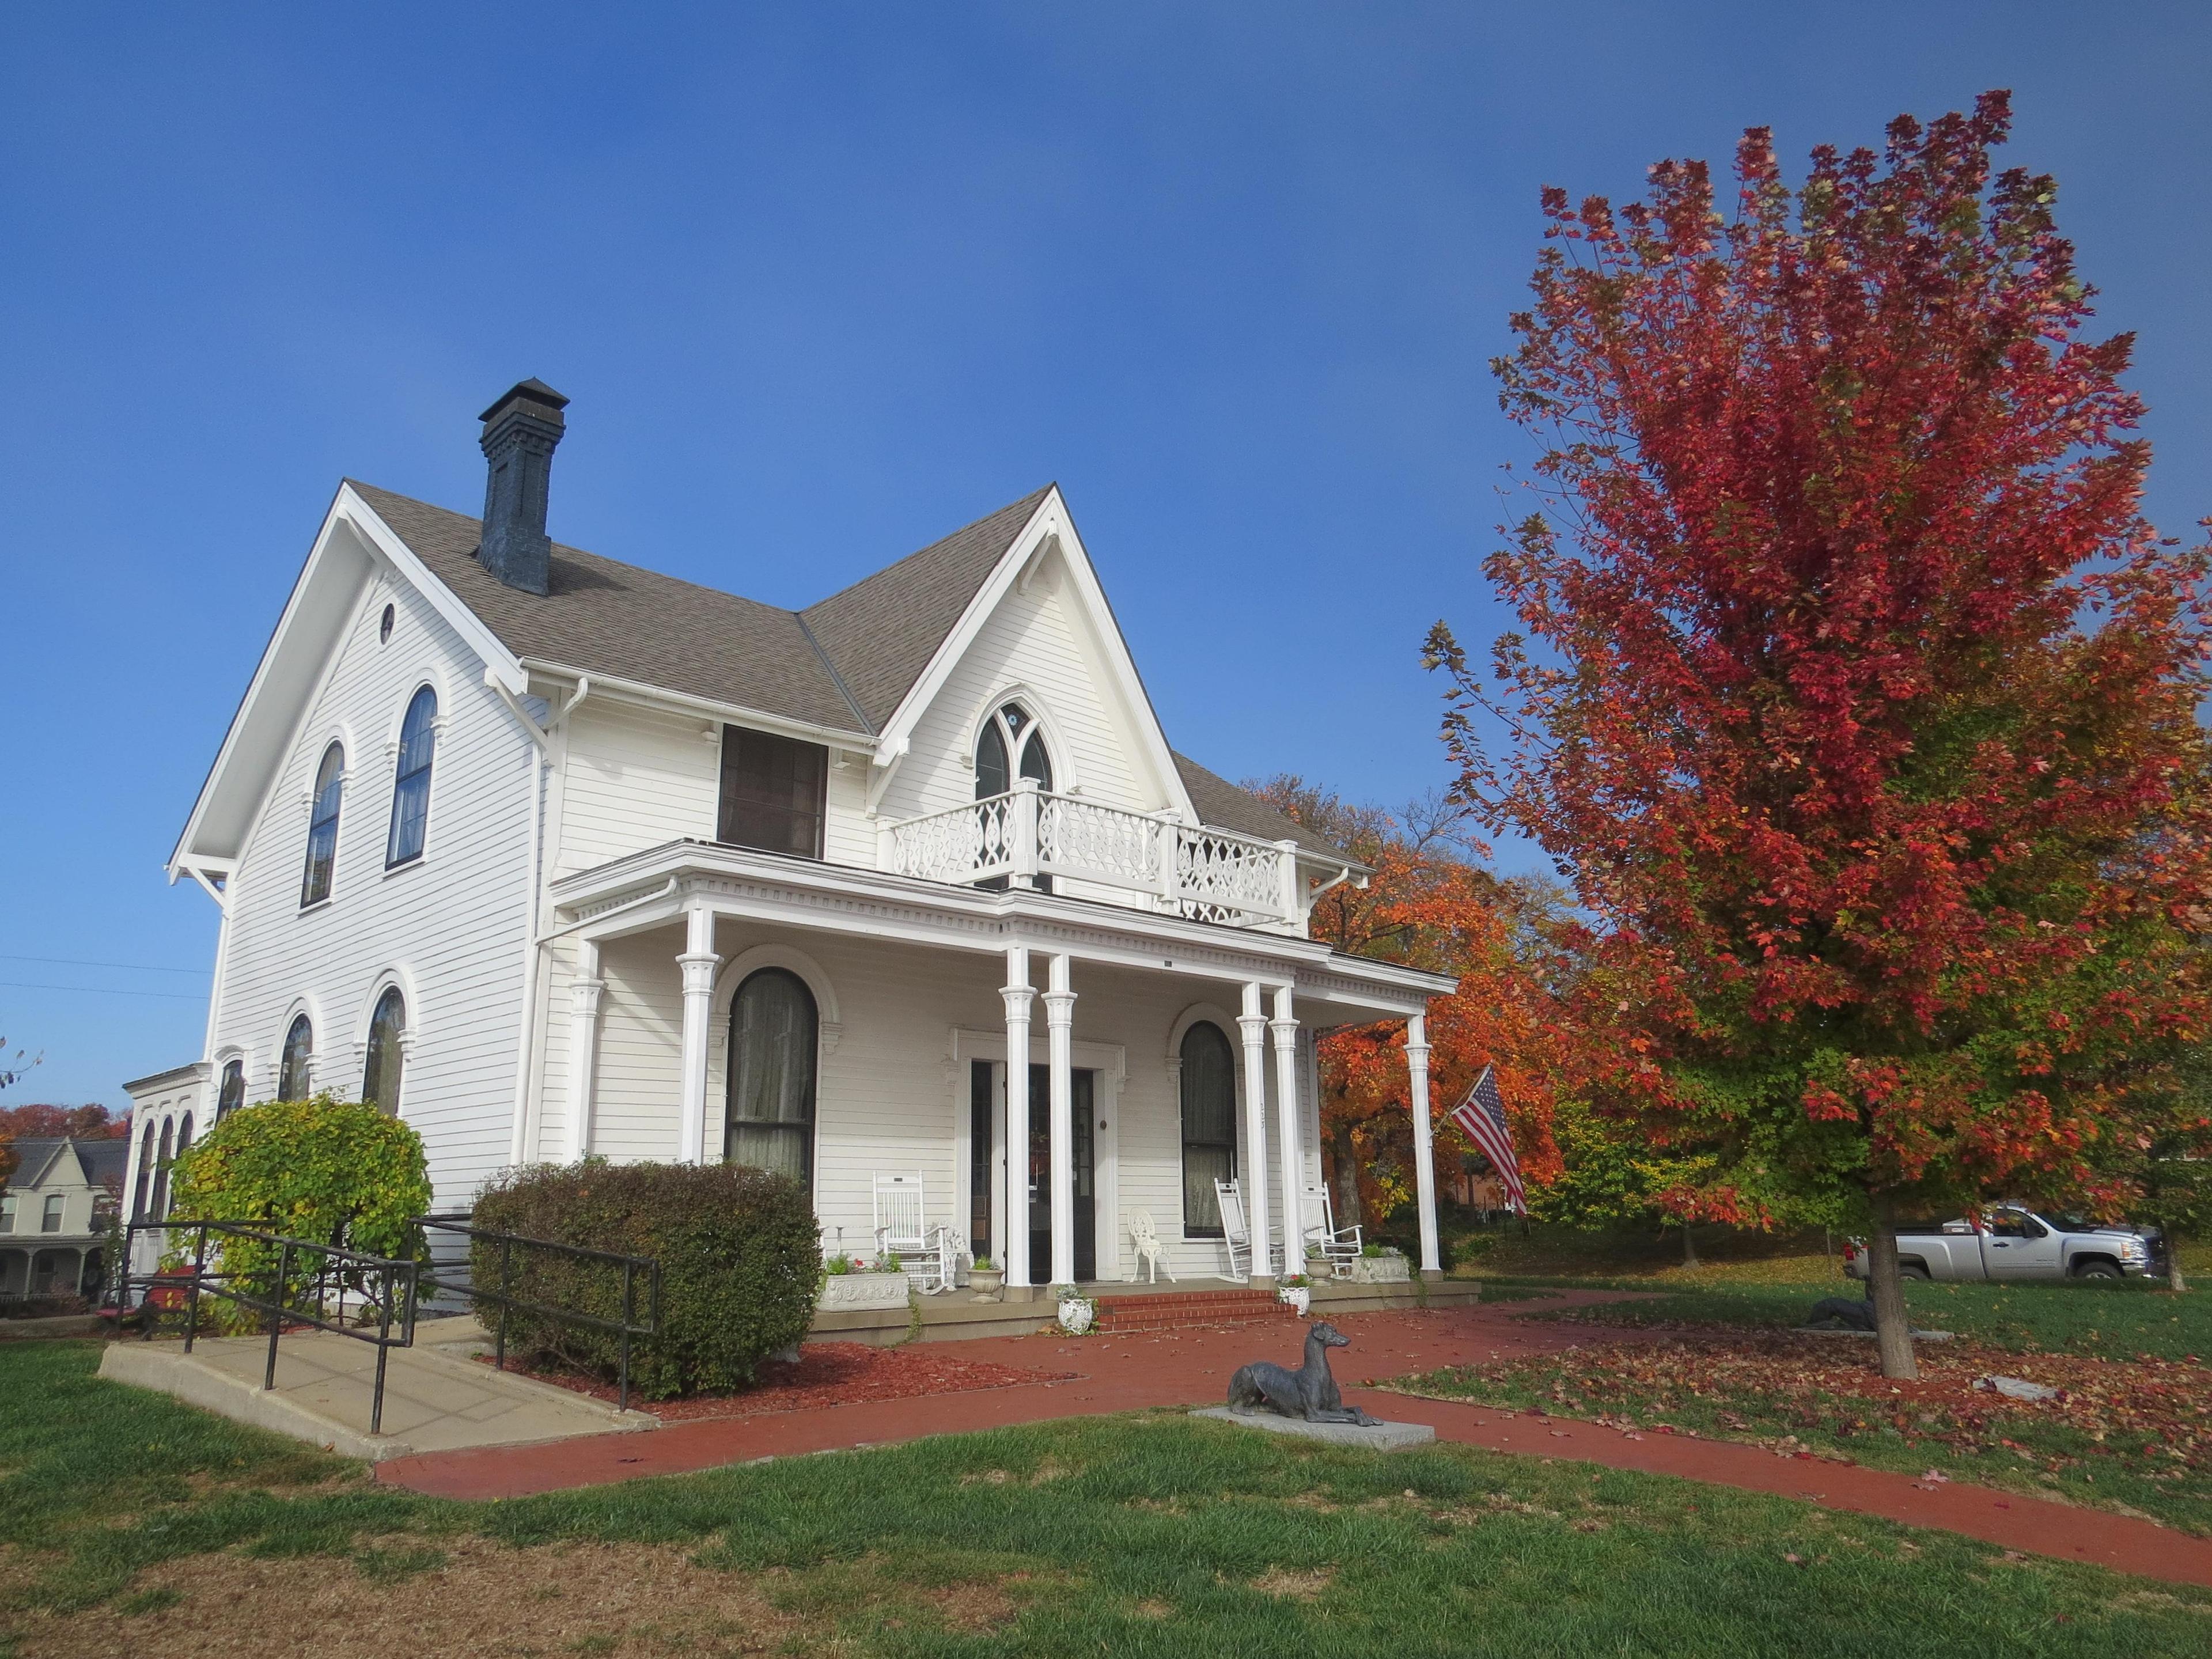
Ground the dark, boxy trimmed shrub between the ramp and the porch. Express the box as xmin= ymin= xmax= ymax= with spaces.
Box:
xmin=469 ymin=1161 xmax=823 ymax=1400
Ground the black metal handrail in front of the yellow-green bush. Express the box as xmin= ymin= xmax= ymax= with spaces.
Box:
xmin=118 ymin=1221 xmax=422 ymax=1435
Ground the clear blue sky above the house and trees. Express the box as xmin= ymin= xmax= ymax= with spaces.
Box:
xmin=0 ymin=0 xmax=2212 ymax=1104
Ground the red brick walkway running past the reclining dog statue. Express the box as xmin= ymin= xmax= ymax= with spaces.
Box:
xmin=376 ymin=1292 xmax=2212 ymax=1586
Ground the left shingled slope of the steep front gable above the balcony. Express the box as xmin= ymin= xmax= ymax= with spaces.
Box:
xmin=798 ymin=484 xmax=1053 ymax=730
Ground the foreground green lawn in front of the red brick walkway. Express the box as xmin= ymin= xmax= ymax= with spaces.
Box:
xmin=0 ymin=1343 xmax=2212 ymax=1659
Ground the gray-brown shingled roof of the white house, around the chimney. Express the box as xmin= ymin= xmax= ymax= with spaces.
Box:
xmin=347 ymin=478 xmax=1343 ymax=858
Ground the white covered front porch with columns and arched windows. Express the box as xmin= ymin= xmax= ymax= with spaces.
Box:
xmin=537 ymin=843 xmax=1451 ymax=1312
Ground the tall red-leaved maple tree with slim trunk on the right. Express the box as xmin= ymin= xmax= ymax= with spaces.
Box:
xmin=1429 ymin=93 xmax=2207 ymax=1376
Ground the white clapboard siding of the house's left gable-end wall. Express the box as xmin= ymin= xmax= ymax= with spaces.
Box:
xmin=208 ymin=579 xmax=537 ymax=1203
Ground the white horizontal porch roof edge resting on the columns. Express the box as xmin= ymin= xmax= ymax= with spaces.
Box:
xmin=548 ymin=840 xmax=1458 ymax=1024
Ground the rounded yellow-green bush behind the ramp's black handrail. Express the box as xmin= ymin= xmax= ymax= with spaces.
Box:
xmin=166 ymin=1095 xmax=429 ymax=1330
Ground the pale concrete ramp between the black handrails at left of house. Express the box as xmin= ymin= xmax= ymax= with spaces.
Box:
xmin=100 ymin=1319 xmax=659 ymax=1462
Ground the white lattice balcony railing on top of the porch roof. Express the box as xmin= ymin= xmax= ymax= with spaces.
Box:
xmin=880 ymin=781 xmax=1301 ymax=927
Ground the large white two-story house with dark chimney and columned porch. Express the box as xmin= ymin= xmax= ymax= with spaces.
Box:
xmin=135 ymin=380 xmax=1451 ymax=1287
